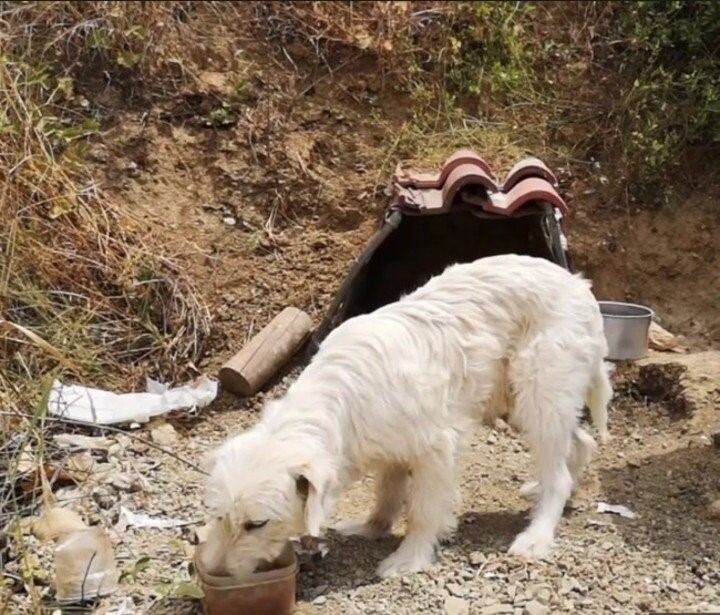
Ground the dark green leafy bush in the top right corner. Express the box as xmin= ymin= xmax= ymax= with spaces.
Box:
xmin=612 ymin=0 xmax=720 ymax=192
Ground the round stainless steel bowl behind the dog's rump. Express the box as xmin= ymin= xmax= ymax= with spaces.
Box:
xmin=598 ymin=301 xmax=654 ymax=361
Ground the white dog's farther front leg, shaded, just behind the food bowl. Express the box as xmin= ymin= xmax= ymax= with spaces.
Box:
xmin=335 ymin=464 xmax=409 ymax=538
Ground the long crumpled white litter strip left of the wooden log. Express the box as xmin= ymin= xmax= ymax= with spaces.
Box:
xmin=48 ymin=376 xmax=218 ymax=425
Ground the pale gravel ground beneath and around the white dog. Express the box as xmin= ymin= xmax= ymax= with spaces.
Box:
xmin=9 ymin=358 xmax=720 ymax=615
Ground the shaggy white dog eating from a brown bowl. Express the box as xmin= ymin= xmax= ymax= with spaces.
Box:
xmin=204 ymin=255 xmax=612 ymax=577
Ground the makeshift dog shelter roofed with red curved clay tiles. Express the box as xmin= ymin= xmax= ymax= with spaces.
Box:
xmin=309 ymin=149 xmax=569 ymax=353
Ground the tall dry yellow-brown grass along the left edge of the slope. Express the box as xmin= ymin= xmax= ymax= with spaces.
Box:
xmin=0 ymin=2 xmax=209 ymax=568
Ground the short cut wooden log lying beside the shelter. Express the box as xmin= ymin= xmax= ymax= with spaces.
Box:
xmin=219 ymin=307 xmax=312 ymax=397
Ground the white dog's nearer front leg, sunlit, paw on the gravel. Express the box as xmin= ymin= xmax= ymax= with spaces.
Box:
xmin=377 ymin=442 xmax=456 ymax=577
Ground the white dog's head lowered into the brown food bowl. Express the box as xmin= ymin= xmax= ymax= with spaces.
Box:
xmin=201 ymin=424 xmax=331 ymax=576
